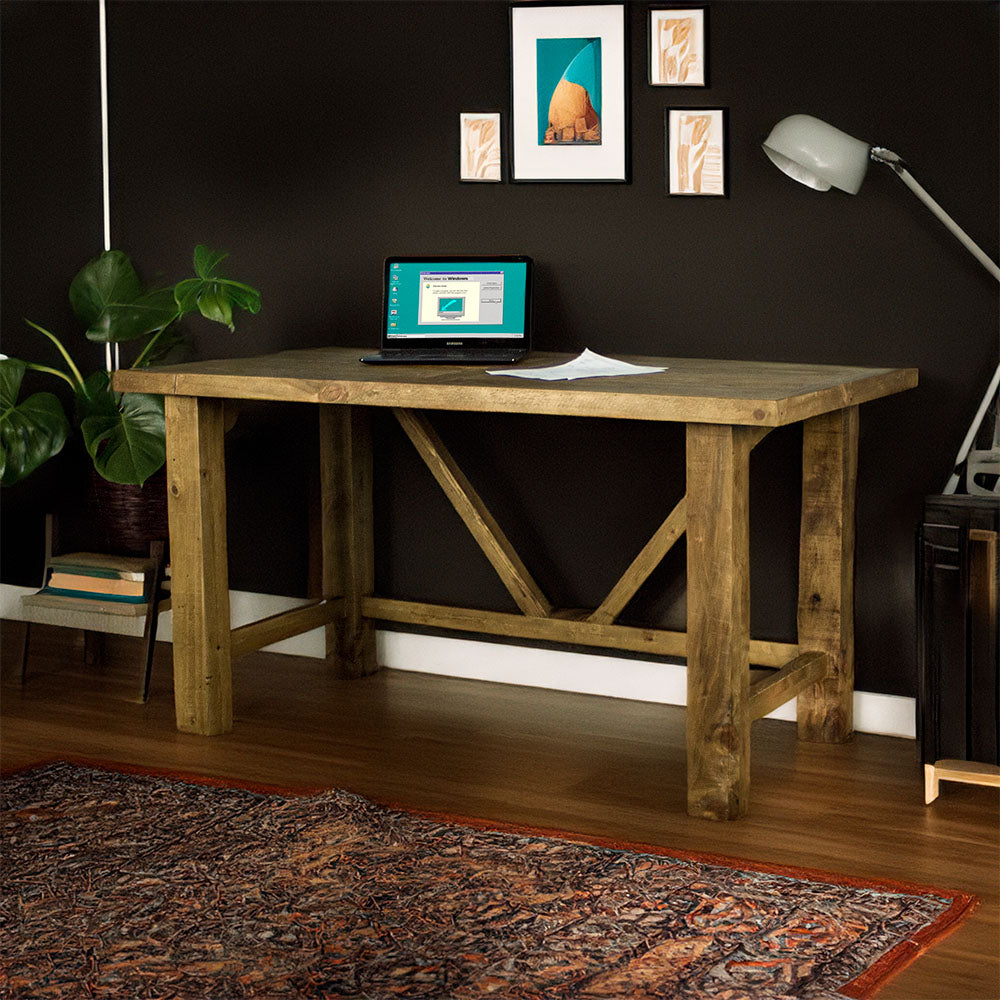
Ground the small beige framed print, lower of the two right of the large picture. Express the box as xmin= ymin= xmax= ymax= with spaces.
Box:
xmin=664 ymin=108 xmax=729 ymax=198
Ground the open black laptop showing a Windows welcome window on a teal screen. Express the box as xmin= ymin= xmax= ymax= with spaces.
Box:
xmin=361 ymin=255 xmax=532 ymax=365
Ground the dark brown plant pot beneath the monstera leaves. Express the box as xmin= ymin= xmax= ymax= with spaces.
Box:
xmin=88 ymin=468 xmax=168 ymax=556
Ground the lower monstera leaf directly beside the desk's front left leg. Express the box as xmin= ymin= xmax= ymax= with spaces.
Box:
xmin=78 ymin=372 xmax=167 ymax=485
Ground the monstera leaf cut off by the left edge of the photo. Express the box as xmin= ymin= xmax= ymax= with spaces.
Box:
xmin=0 ymin=358 xmax=69 ymax=486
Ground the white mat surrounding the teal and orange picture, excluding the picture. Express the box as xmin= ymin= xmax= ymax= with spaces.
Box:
xmin=511 ymin=4 xmax=626 ymax=181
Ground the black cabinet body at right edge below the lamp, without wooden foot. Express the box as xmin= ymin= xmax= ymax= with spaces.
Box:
xmin=917 ymin=495 xmax=1000 ymax=765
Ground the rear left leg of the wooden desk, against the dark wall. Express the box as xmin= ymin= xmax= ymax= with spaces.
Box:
xmin=320 ymin=405 xmax=378 ymax=677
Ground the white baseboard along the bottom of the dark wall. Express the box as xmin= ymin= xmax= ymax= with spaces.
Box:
xmin=0 ymin=584 xmax=916 ymax=739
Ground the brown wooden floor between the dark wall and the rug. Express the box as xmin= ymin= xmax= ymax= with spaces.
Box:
xmin=0 ymin=622 xmax=1000 ymax=1000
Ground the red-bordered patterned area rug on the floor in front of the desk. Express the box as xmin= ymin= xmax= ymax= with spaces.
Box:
xmin=0 ymin=764 xmax=974 ymax=1000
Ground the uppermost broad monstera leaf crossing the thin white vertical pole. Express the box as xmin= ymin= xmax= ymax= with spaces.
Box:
xmin=69 ymin=250 xmax=178 ymax=343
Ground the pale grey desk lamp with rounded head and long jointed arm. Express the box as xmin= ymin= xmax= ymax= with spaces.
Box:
xmin=763 ymin=115 xmax=1000 ymax=493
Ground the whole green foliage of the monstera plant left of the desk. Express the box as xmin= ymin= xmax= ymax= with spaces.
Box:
xmin=0 ymin=246 xmax=260 ymax=486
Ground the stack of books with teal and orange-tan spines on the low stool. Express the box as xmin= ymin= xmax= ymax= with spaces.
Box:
xmin=23 ymin=552 xmax=154 ymax=616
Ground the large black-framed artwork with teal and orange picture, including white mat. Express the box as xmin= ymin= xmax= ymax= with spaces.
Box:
xmin=510 ymin=3 xmax=629 ymax=183
